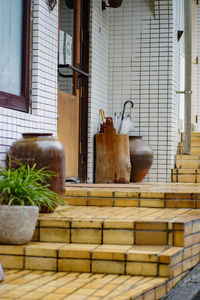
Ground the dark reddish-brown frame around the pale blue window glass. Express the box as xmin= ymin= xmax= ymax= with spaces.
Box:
xmin=0 ymin=0 xmax=30 ymax=112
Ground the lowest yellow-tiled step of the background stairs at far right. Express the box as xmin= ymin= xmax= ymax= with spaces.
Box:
xmin=172 ymin=169 xmax=200 ymax=183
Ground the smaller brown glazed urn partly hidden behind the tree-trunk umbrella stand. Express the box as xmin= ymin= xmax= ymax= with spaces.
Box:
xmin=129 ymin=136 xmax=153 ymax=182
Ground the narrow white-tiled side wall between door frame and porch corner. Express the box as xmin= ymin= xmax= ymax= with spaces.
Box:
xmin=88 ymin=0 xmax=110 ymax=182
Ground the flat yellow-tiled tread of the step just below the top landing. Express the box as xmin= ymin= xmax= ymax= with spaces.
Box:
xmin=39 ymin=206 xmax=200 ymax=221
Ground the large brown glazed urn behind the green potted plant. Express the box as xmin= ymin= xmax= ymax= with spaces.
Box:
xmin=9 ymin=133 xmax=65 ymax=202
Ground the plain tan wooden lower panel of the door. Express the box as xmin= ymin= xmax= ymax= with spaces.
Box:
xmin=58 ymin=91 xmax=79 ymax=178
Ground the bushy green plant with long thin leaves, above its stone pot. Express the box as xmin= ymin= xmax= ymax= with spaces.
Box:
xmin=0 ymin=162 xmax=65 ymax=211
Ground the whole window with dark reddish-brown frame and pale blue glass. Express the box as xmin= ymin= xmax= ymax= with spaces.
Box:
xmin=0 ymin=0 xmax=30 ymax=112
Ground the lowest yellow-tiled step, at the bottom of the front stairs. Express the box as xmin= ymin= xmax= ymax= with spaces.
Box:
xmin=0 ymin=270 xmax=177 ymax=300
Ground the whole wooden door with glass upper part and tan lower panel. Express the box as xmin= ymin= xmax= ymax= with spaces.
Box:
xmin=58 ymin=0 xmax=81 ymax=179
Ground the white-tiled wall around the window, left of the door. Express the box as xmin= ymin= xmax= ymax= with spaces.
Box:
xmin=0 ymin=0 xmax=58 ymax=164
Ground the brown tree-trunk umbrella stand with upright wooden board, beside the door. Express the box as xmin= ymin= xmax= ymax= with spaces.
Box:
xmin=95 ymin=118 xmax=131 ymax=183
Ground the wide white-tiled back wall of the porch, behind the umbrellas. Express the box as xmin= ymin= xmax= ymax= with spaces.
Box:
xmin=108 ymin=0 xmax=180 ymax=181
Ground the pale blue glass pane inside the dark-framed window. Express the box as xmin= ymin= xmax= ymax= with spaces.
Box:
xmin=0 ymin=0 xmax=23 ymax=96
